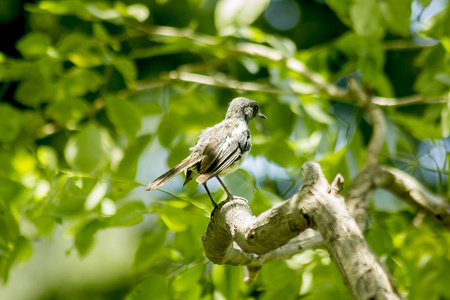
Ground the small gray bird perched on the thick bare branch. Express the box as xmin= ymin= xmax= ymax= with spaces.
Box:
xmin=146 ymin=97 xmax=266 ymax=207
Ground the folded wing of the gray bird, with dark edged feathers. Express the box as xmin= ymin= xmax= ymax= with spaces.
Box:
xmin=196 ymin=127 xmax=251 ymax=183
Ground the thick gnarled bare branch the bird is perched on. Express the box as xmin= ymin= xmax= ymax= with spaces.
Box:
xmin=203 ymin=163 xmax=400 ymax=299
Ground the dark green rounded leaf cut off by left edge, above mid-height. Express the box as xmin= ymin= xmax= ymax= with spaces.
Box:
xmin=0 ymin=103 xmax=21 ymax=143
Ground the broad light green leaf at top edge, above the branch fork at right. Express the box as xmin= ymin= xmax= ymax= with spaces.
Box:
xmin=350 ymin=0 xmax=385 ymax=39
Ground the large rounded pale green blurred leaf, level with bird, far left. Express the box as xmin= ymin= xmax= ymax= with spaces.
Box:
xmin=64 ymin=123 xmax=110 ymax=173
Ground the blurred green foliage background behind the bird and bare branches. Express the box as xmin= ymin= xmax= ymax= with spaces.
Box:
xmin=0 ymin=0 xmax=450 ymax=300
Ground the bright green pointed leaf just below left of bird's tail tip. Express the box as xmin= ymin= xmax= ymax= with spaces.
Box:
xmin=108 ymin=201 xmax=147 ymax=227
